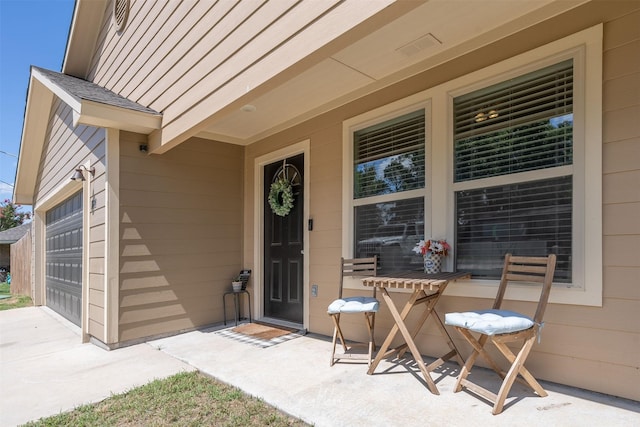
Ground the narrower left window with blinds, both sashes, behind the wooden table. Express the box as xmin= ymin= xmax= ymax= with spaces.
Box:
xmin=353 ymin=109 xmax=425 ymax=272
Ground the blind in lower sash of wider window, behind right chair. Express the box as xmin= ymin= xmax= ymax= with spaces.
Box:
xmin=455 ymin=176 xmax=573 ymax=282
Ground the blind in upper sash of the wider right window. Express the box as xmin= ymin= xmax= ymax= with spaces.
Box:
xmin=454 ymin=60 xmax=573 ymax=182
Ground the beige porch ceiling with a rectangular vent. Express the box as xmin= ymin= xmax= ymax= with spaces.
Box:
xmin=198 ymin=0 xmax=586 ymax=145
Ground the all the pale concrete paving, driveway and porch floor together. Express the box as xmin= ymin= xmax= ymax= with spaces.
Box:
xmin=0 ymin=308 xmax=640 ymax=427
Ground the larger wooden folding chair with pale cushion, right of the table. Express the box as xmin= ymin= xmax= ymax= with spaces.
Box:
xmin=445 ymin=254 xmax=556 ymax=415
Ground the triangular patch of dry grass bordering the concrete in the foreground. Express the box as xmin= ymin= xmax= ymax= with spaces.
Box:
xmin=26 ymin=372 xmax=308 ymax=427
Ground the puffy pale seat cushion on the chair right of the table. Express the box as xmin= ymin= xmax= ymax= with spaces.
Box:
xmin=444 ymin=310 xmax=534 ymax=335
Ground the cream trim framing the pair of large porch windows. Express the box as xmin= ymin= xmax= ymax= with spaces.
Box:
xmin=342 ymin=24 xmax=603 ymax=306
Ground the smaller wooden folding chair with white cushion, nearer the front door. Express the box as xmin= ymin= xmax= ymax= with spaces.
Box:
xmin=327 ymin=257 xmax=380 ymax=366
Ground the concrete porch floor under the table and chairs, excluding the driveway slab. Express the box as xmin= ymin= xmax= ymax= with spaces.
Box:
xmin=149 ymin=322 xmax=640 ymax=427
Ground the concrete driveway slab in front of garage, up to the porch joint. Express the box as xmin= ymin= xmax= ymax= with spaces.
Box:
xmin=0 ymin=307 xmax=195 ymax=427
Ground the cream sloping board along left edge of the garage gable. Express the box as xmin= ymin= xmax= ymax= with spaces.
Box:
xmin=13 ymin=74 xmax=53 ymax=205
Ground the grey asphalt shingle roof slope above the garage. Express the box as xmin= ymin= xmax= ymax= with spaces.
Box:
xmin=33 ymin=66 xmax=160 ymax=115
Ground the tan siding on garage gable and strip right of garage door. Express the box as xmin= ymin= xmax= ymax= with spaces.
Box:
xmin=36 ymin=98 xmax=105 ymax=340
